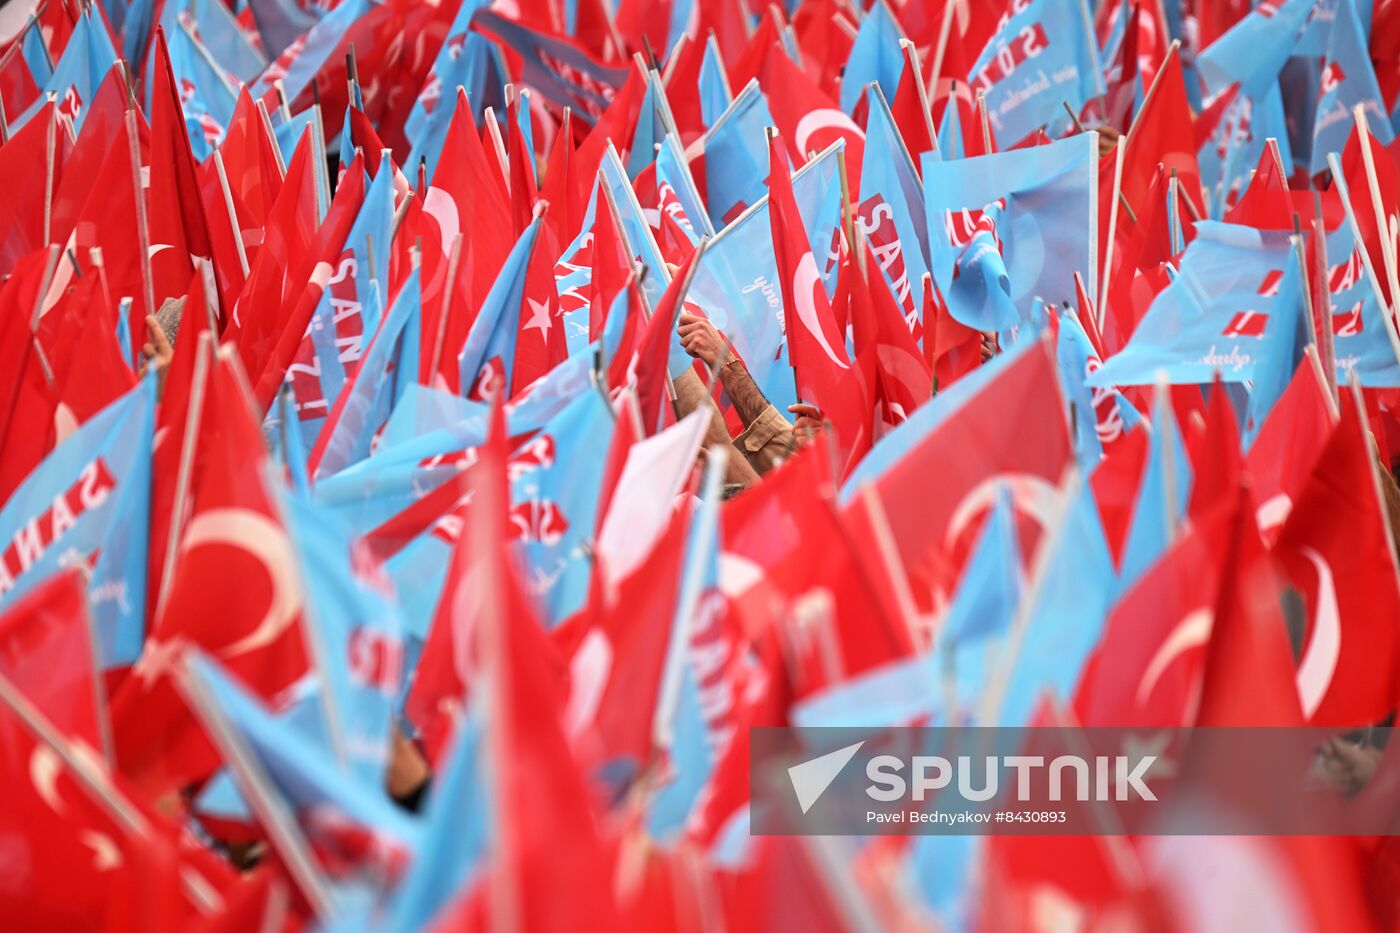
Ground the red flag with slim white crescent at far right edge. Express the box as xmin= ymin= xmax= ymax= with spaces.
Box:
xmin=1274 ymin=389 xmax=1400 ymax=726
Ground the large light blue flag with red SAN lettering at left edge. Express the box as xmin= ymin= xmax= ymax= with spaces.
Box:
xmin=0 ymin=378 xmax=155 ymax=670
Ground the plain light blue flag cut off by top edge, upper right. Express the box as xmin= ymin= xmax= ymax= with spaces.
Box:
xmin=1196 ymin=0 xmax=1316 ymax=99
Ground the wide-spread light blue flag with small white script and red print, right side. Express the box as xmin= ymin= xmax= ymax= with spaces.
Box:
xmin=1086 ymin=221 xmax=1289 ymax=388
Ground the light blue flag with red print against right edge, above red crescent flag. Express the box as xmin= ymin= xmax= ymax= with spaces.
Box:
xmin=1327 ymin=178 xmax=1400 ymax=388
